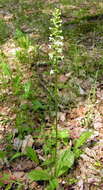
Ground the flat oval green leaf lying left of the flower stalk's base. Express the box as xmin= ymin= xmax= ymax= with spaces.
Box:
xmin=28 ymin=170 xmax=51 ymax=181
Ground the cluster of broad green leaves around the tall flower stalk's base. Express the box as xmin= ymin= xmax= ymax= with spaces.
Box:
xmin=28 ymin=131 xmax=92 ymax=190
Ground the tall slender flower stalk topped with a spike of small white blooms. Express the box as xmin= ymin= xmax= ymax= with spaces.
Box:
xmin=49 ymin=8 xmax=63 ymax=177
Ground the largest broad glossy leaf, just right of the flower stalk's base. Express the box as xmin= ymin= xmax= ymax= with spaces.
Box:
xmin=57 ymin=150 xmax=74 ymax=177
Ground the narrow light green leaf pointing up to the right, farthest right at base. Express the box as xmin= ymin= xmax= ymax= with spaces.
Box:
xmin=74 ymin=131 xmax=92 ymax=150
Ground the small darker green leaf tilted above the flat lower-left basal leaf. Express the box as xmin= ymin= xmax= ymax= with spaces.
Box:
xmin=26 ymin=147 xmax=39 ymax=164
